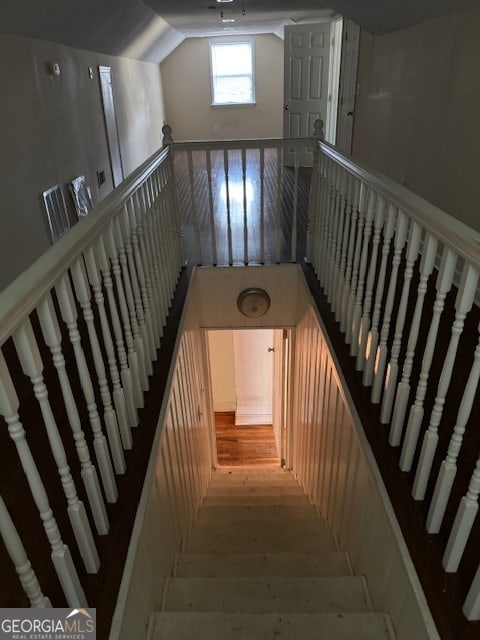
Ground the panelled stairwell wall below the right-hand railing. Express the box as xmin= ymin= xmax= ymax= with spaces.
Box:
xmin=287 ymin=278 xmax=439 ymax=640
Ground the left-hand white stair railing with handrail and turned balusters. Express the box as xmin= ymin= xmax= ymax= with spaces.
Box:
xmin=0 ymin=139 xmax=184 ymax=607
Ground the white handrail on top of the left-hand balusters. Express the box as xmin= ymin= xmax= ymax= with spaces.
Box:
xmin=0 ymin=147 xmax=171 ymax=346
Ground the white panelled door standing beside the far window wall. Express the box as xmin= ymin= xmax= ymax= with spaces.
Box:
xmin=284 ymin=22 xmax=331 ymax=165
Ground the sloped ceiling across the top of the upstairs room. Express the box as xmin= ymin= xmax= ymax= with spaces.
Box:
xmin=0 ymin=0 xmax=478 ymax=62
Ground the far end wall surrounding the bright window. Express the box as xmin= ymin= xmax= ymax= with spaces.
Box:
xmin=160 ymin=34 xmax=283 ymax=140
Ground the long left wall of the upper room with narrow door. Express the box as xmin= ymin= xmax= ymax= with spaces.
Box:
xmin=0 ymin=35 xmax=164 ymax=290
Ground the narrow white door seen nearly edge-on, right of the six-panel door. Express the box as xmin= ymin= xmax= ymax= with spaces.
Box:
xmin=337 ymin=20 xmax=360 ymax=154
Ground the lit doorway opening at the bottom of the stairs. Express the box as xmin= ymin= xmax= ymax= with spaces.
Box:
xmin=207 ymin=329 xmax=286 ymax=467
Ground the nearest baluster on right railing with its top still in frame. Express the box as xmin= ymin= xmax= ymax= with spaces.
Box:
xmin=412 ymin=264 xmax=479 ymax=500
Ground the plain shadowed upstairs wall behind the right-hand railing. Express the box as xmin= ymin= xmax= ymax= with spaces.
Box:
xmin=353 ymin=9 xmax=480 ymax=230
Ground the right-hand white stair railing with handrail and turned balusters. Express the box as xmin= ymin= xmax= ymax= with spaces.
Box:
xmin=307 ymin=136 xmax=480 ymax=619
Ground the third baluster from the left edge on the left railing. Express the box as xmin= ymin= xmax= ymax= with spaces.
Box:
xmin=12 ymin=318 xmax=100 ymax=573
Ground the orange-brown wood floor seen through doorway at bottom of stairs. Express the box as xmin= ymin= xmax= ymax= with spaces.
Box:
xmin=215 ymin=411 xmax=280 ymax=467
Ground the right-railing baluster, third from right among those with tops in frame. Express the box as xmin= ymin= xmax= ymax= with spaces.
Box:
xmin=389 ymin=234 xmax=438 ymax=447
